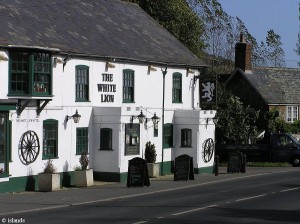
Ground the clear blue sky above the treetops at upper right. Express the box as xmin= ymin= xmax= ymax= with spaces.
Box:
xmin=218 ymin=0 xmax=300 ymax=67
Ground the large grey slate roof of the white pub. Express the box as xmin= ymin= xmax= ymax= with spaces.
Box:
xmin=0 ymin=0 xmax=205 ymax=68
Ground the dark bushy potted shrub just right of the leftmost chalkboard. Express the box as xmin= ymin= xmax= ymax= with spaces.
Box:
xmin=145 ymin=141 xmax=160 ymax=177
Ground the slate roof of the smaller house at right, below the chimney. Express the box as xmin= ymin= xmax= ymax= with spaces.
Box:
xmin=237 ymin=68 xmax=300 ymax=104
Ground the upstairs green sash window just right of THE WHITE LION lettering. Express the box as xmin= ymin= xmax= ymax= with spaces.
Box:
xmin=123 ymin=69 xmax=134 ymax=103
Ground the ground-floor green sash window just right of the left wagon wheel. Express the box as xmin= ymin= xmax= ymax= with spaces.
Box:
xmin=43 ymin=119 xmax=58 ymax=159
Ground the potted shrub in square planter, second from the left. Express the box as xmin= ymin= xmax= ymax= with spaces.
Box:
xmin=75 ymin=151 xmax=94 ymax=187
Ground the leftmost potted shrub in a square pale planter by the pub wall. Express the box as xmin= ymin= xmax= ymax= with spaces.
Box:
xmin=38 ymin=159 xmax=60 ymax=192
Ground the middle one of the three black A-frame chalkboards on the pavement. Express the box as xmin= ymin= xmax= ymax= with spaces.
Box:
xmin=174 ymin=155 xmax=195 ymax=181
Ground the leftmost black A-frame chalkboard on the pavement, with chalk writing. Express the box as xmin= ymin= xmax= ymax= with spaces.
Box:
xmin=127 ymin=157 xmax=150 ymax=187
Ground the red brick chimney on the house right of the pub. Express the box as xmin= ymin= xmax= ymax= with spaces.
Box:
xmin=235 ymin=33 xmax=252 ymax=71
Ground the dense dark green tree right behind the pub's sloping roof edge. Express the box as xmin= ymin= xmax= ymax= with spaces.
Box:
xmin=124 ymin=0 xmax=205 ymax=56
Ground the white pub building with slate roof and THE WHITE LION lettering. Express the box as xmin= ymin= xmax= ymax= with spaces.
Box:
xmin=0 ymin=0 xmax=216 ymax=192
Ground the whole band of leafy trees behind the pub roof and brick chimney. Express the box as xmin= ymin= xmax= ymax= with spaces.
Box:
xmin=123 ymin=0 xmax=286 ymax=68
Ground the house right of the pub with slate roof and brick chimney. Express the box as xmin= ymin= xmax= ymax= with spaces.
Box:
xmin=226 ymin=35 xmax=300 ymax=122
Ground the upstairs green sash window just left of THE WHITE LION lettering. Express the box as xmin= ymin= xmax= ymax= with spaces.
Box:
xmin=75 ymin=65 xmax=89 ymax=102
